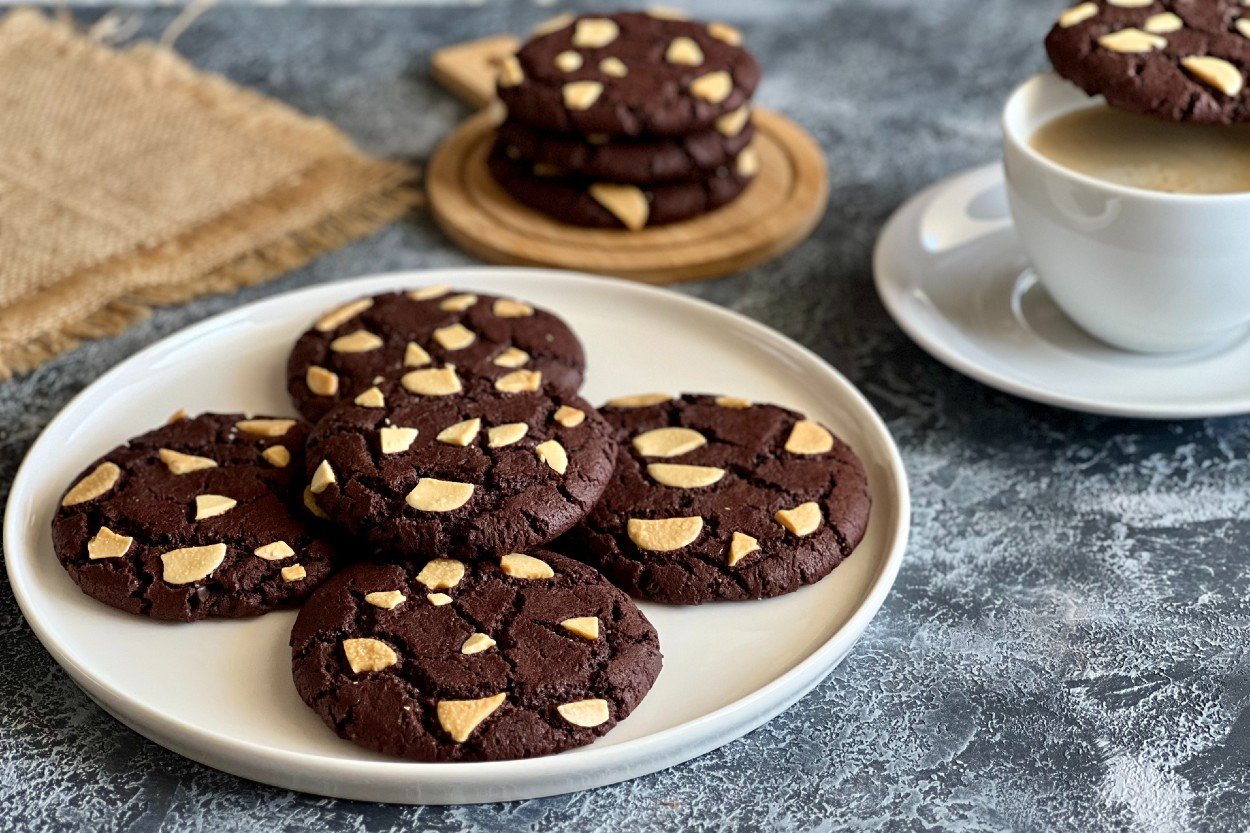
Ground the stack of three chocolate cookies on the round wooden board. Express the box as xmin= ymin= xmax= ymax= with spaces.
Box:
xmin=489 ymin=11 xmax=760 ymax=231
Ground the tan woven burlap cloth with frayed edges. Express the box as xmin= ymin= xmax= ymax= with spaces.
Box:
xmin=0 ymin=10 xmax=418 ymax=379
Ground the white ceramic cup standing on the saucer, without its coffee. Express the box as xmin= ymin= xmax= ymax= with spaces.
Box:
xmin=1003 ymin=74 xmax=1250 ymax=353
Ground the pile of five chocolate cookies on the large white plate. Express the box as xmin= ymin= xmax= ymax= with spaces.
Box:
xmin=53 ymin=286 xmax=870 ymax=762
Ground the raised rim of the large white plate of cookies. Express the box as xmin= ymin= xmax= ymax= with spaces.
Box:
xmin=4 ymin=266 xmax=911 ymax=803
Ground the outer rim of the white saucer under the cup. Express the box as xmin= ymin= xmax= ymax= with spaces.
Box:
xmin=873 ymin=163 xmax=1250 ymax=419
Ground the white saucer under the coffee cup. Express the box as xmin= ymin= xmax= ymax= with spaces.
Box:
xmin=873 ymin=164 xmax=1250 ymax=419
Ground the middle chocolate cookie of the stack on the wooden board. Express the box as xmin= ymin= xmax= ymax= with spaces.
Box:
xmin=498 ymin=106 xmax=755 ymax=185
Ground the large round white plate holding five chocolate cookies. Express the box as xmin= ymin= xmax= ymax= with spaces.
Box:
xmin=4 ymin=268 xmax=910 ymax=803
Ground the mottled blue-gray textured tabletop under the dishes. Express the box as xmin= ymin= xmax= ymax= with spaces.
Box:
xmin=0 ymin=0 xmax=1250 ymax=832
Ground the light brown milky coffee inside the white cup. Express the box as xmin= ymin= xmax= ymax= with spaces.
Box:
xmin=1029 ymin=106 xmax=1250 ymax=194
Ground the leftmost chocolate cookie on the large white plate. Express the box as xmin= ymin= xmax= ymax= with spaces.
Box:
xmin=53 ymin=414 xmax=336 ymax=622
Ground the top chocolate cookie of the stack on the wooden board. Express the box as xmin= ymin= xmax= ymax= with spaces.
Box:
xmin=498 ymin=11 xmax=760 ymax=136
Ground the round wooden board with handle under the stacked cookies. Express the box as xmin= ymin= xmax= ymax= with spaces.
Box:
xmin=426 ymin=38 xmax=829 ymax=284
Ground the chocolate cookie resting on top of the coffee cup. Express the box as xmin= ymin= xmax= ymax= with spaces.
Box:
xmin=1046 ymin=0 xmax=1250 ymax=124
